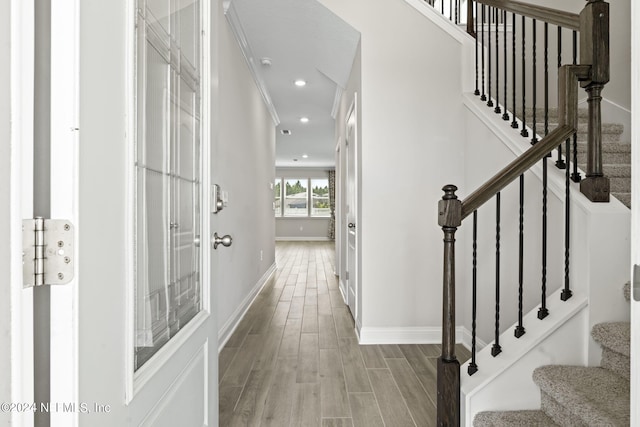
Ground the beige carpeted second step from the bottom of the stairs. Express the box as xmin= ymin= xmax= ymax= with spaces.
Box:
xmin=533 ymin=365 xmax=630 ymax=426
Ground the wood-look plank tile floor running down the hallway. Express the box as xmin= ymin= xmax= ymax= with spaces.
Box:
xmin=219 ymin=242 xmax=469 ymax=427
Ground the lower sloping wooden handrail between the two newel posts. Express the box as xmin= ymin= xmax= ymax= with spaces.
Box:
xmin=462 ymin=125 xmax=576 ymax=219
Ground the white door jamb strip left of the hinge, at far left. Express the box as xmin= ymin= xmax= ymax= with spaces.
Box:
xmin=9 ymin=0 xmax=35 ymax=427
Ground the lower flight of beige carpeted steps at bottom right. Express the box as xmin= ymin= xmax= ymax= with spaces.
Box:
xmin=473 ymin=284 xmax=630 ymax=427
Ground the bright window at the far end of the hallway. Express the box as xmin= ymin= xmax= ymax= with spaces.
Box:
xmin=274 ymin=178 xmax=331 ymax=218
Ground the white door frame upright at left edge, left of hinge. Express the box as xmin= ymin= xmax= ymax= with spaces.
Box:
xmin=5 ymin=0 xmax=35 ymax=426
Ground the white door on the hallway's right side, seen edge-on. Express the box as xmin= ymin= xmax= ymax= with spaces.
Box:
xmin=345 ymin=100 xmax=358 ymax=320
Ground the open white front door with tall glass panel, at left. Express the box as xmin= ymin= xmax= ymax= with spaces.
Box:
xmin=47 ymin=0 xmax=219 ymax=427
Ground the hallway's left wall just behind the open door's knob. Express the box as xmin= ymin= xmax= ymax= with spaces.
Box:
xmin=212 ymin=13 xmax=275 ymax=346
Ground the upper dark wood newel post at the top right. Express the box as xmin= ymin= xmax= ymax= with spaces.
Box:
xmin=580 ymin=0 xmax=610 ymax=202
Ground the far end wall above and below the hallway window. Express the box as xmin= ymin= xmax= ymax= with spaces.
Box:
xmin=276 ymin=168 xmax=336 ymax=241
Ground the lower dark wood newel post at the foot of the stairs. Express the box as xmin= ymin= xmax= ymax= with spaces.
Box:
xmin=437 ymin=185 xmax=462 ymax=426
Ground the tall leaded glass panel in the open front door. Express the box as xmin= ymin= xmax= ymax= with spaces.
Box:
xmin=134 ymin=0 xmax=202 ymax=370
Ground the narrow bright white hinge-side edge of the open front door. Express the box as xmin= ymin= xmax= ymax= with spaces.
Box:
xmin=50 ymin=0 xmax=82 ymax=427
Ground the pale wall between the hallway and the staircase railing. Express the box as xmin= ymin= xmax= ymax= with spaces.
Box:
xmin=321 ymin=0 xmax=464 ymax=341
